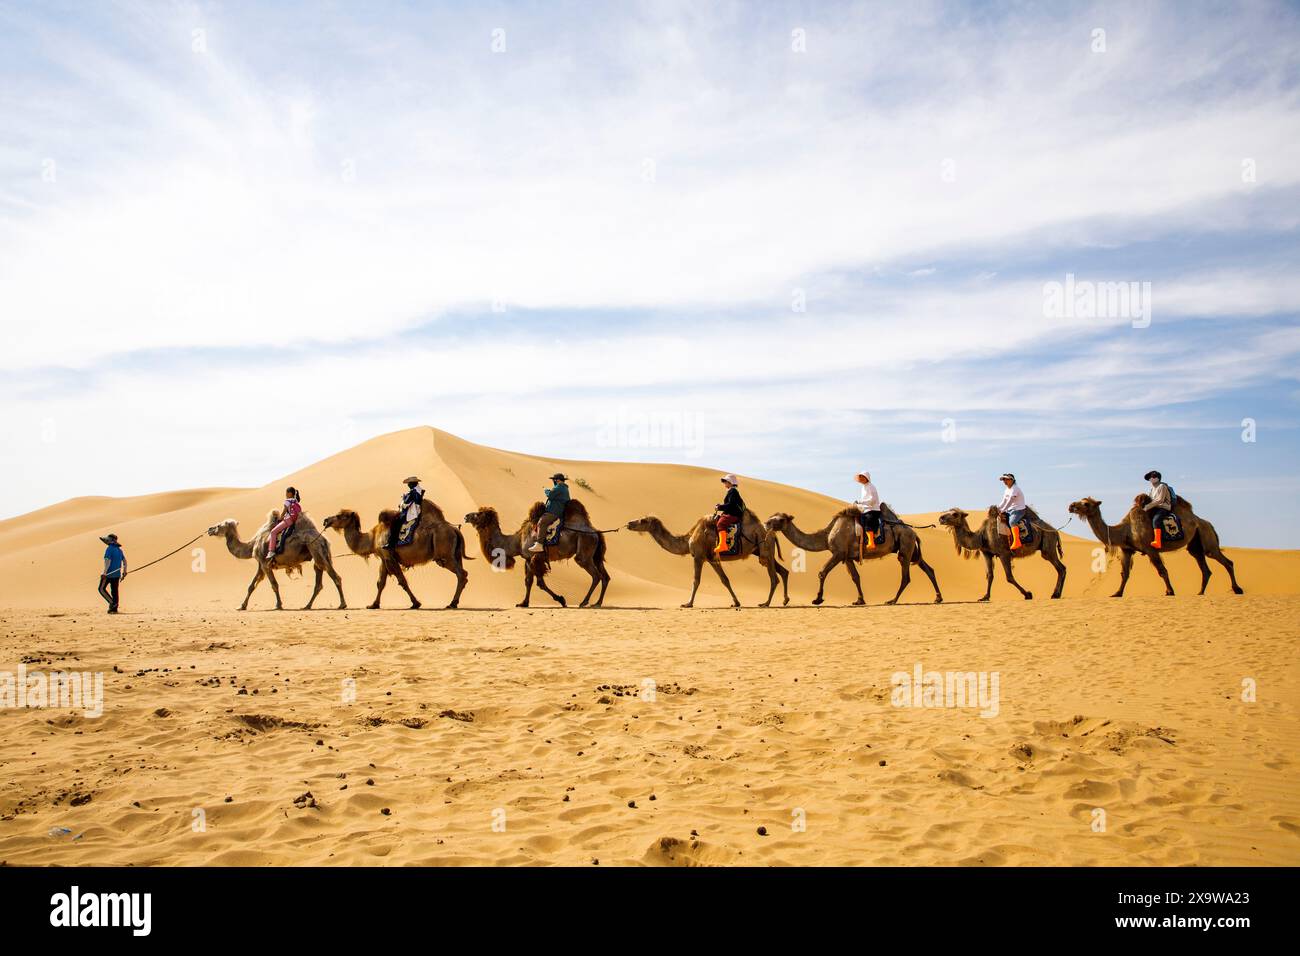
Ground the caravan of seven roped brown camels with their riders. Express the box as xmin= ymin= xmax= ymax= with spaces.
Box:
xmin=197 ymin=470 xmax=1243 ymax=610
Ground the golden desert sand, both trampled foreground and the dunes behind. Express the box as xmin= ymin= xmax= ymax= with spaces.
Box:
xmin=0 ymin=429 xmax=1300 ymax=865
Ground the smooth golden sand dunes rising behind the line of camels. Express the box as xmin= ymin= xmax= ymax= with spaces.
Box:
xmin=0 ymin=428 xmax=1300 ymax=609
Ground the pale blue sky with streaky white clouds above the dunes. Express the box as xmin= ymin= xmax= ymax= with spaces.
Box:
xmin=0 ymin=0 xmax=1300 ymax=548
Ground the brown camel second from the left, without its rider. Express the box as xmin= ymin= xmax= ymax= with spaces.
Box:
xmin=325 ymin=501 xmax=473 ymax=610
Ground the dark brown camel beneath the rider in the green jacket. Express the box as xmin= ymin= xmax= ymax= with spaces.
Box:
xmin=465 ymin=498 xmax=610 ymax=607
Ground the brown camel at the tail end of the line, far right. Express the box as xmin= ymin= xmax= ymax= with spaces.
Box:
xmin=1070 ymin=494 xmax=1245 ymax=597
